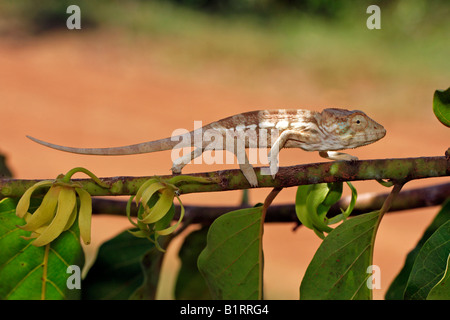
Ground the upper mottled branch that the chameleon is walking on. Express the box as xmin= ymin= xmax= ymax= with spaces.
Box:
xmin=0 ymin=157 xmax=450 ymax=198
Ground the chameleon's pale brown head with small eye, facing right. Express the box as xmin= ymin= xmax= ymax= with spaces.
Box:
xmin=321 ymin=109 xmax=386 ymax=150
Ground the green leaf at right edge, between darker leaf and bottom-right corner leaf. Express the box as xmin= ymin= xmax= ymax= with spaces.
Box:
xmin=405 ymin=220 xmax=450 ymax=300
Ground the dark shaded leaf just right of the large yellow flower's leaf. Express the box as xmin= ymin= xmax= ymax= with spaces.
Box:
xmin=82 ymin=231 xmax=154 ymax=300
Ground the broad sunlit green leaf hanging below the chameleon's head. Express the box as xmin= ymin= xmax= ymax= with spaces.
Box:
xmin=300 ymin=211 xmax=379 ymax=300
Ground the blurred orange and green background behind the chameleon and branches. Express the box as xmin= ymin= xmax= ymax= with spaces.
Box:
xmin=0 ymin=0 xmax=450 ymax=299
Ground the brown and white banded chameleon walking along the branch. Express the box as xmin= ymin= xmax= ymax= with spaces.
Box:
xmin=27 ymin=108 xmax=386 ymax=187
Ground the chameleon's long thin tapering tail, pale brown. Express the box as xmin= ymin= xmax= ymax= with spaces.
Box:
xmin=27 ymin=136 xmax=184 ymax=156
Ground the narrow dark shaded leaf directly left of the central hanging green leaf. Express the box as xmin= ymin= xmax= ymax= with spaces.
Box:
xmin=175 ymin=227 xmax=211 ymax=300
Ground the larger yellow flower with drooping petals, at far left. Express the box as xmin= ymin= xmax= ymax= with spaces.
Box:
xmin=16 ymin=168 xmax=104 ymax=247
